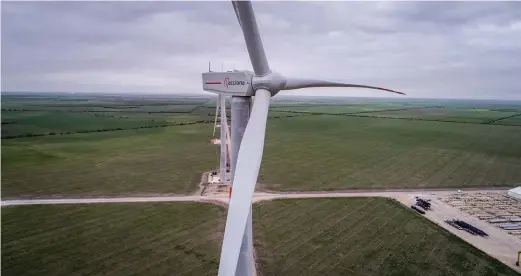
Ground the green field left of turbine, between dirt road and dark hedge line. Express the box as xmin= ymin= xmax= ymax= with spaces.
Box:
xmin=2 ymin=125 xmax=219 ymax=197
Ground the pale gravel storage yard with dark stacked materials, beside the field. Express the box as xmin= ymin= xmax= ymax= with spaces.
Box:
xmin=394 ymin=190 xmax=521 ymax=270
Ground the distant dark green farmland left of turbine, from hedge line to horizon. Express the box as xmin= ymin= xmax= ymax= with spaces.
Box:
xmin=2 ymin=97 xmax=213 ymax=138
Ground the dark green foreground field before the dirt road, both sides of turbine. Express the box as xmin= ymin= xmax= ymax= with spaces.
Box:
xmin=1 ymin=198 xmax=518 ymax=276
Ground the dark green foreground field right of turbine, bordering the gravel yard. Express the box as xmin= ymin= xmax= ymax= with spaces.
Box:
xmin=253 ymin=198 xmax=518 ymax=276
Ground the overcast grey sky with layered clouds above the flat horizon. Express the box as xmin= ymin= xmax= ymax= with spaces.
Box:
xmin=1 ymin=1 xmax=521 ymax=99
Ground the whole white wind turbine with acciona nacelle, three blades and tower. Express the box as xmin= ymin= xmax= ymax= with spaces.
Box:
xmin=202 ymin=1 xmax=404 ymax=276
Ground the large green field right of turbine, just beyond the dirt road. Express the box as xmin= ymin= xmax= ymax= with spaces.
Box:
xmin=260 ymin=116 xmax=521 ymax=190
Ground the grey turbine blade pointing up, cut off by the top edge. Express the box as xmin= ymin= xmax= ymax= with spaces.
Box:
xmin=233 ymin=1 xmax=270 ymax=76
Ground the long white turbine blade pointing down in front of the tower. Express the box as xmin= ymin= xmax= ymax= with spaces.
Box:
xmin=219 ymin=89 xmax=271 ymax=276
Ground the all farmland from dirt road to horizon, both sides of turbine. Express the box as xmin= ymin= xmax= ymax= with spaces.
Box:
xmin=2 ymin=95 xmax=521 ymax=198
